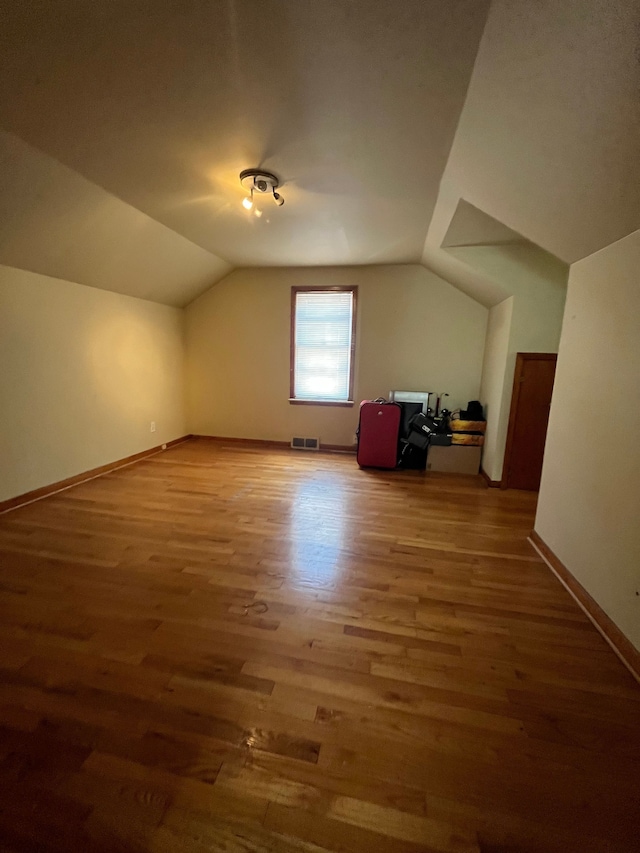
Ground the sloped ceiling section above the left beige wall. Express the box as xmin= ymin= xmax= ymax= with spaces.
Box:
xmin=0 ymin=131 xmax=231 ymax=307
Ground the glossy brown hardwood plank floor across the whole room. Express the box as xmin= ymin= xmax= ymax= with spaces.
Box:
xmin=0 ymin=441 xmax=640 ymax=853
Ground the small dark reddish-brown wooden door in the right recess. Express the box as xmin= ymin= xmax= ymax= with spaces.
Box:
xmin=502 ymin=352 xmax=557 ymax=491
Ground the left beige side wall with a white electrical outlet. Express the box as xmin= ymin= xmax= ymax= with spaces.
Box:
xmin=0 ymin=266 xmax=186 ymax=500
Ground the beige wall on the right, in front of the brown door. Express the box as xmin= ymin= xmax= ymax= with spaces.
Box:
xmin=535 ymin=231 xmax=640 ymax=649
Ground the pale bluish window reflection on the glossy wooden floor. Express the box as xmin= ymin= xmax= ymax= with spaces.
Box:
xmin=289 ymin=472 xmax=346 ymax=588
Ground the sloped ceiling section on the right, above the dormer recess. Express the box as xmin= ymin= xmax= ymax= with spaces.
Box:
xmin=430 ymin=0 xmax=640 ymax=263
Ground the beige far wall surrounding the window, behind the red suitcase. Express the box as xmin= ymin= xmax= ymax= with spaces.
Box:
xmin=186 ymin=265 xmax=488 ymax=445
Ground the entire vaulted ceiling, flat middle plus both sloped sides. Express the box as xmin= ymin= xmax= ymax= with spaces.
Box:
xmin=0 ymin=0 xmax=640 ymax=305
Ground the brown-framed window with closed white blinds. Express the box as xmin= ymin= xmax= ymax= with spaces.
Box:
xmin=290 ymin=287 xmax=357 ymax=406
